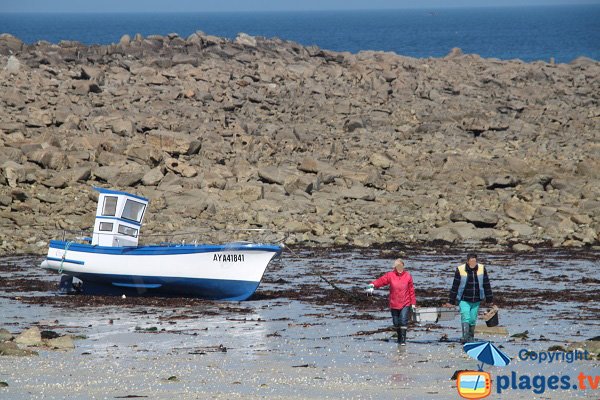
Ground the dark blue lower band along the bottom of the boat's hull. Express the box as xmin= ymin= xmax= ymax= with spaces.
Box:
xmin=70 ymin=273 xmax=260 ymax=301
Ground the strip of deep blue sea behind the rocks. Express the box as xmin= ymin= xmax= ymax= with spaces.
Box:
xmin=0 ymin=4 xmax=600 ymax=62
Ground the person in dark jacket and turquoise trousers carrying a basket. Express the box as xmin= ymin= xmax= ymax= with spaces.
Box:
xmin=444 ymin=254 xmax=494 ymax=343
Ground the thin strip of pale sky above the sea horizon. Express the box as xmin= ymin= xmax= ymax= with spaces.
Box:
xmin=0 ymin=0 xmax=600 ymax=13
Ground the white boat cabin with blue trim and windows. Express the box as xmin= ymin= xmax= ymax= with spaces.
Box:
xmin=92 ymin=188 xmax=148 ymax=247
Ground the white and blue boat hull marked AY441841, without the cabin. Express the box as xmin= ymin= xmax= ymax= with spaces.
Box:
xmin=42 ymin=241 xmax=281 ymax=300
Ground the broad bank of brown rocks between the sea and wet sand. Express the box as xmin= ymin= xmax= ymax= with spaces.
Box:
xmin=0 ymin=32 xmax=600 ymax=254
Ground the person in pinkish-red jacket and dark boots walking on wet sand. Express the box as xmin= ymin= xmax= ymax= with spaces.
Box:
xmin=367 ymin=259 xmax=417 ymax=346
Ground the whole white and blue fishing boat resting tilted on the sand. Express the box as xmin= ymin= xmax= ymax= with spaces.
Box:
xmin=41 ymin=188 xmax=282 ymax=301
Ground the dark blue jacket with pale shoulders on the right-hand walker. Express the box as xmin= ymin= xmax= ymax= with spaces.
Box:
xmin=449 ymin=264 xmax=494 ymax=304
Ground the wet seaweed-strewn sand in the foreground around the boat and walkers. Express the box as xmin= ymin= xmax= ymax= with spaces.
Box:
xmin=0 ymin=249 xmax=600 ymax=399
